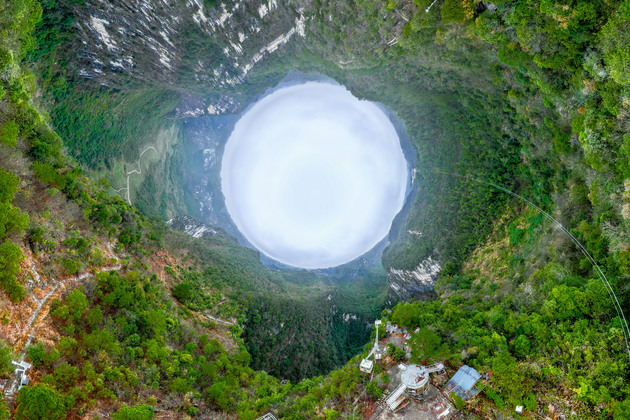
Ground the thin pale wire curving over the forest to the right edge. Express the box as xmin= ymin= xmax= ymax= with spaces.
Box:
xmin=425 ymin=170 xmax=630 ymax=360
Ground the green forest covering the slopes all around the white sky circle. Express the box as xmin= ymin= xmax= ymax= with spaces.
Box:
xmin=0 ymin=0 xmax=630 ymax=420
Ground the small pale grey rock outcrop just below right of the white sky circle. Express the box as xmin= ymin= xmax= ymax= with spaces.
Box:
xmin=387 ymin=257 xmax=441 ymax=304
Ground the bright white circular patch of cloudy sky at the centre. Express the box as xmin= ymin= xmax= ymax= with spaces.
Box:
xmin=221 ymin=82 xmax=407 ymax=269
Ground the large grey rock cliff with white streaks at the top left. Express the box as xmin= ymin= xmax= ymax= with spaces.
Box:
xmin=72 ymin=0 xmax=308 ymax=91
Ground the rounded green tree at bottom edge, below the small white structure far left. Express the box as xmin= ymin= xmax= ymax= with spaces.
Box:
xmin=15 ymin=384 xmax=66 ymax=420
